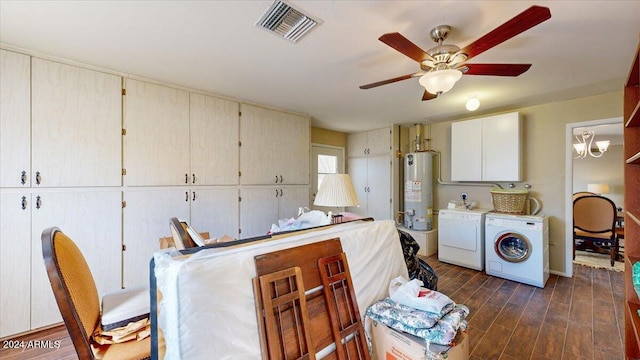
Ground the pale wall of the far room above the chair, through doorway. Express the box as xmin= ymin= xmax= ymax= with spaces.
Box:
xmin=573 ymin=144 xmax=624 ymax=208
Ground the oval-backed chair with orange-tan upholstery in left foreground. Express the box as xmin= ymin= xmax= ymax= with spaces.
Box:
xmin=41 ymin=227 xmax=151 ymax=360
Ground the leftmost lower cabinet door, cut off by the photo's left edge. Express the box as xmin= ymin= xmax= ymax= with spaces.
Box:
xmin=0 ymin=192 xmax=31 ymax=338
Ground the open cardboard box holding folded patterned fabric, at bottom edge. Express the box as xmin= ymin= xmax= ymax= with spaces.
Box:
xmin=371 ymin=321 xmax=469 ymax=360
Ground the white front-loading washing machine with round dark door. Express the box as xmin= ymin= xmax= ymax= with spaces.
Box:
xmin=485 ymin=213 xmax=549 ymax=288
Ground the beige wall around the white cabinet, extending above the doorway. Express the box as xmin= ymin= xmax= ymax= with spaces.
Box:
xmin=429 ymin=91 xmax=622 ymax=274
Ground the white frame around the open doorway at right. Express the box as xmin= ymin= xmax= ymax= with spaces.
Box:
xmin=564 ymin=116 xmax=623 ymax=277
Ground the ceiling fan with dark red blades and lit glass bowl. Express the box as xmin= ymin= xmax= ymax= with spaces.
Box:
xmin=360 ymin=6 xmax=551 ymax=101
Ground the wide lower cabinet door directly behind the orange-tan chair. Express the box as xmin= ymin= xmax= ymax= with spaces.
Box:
xmin=31 ymin=189 xmax=122 ymax=328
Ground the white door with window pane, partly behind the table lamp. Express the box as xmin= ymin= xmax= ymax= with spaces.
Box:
xmin=309 ymin=145 xmax=344 ymax=211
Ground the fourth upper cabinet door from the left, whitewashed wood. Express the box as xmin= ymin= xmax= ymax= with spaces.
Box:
xmin=190 ymin=93 xmax=240 ymax=185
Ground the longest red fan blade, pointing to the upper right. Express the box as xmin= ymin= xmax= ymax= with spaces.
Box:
xmin=460 ymin=6 xmax=551 ymax=60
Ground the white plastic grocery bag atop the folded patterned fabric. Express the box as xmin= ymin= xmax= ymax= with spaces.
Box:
xmin=389 ymin=276 xmax=453 ymax=314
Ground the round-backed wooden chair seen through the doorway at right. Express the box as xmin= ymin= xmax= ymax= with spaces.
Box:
xmin=573 ymin=195 xmax=620 ymax=266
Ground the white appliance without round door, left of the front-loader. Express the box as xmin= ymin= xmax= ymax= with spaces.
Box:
xmin=438 ymin=209 xmax=489 ymax=271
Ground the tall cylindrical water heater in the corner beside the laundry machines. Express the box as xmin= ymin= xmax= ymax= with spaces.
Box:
xmin=404 ymin=151 xmax=433 ymax=230
